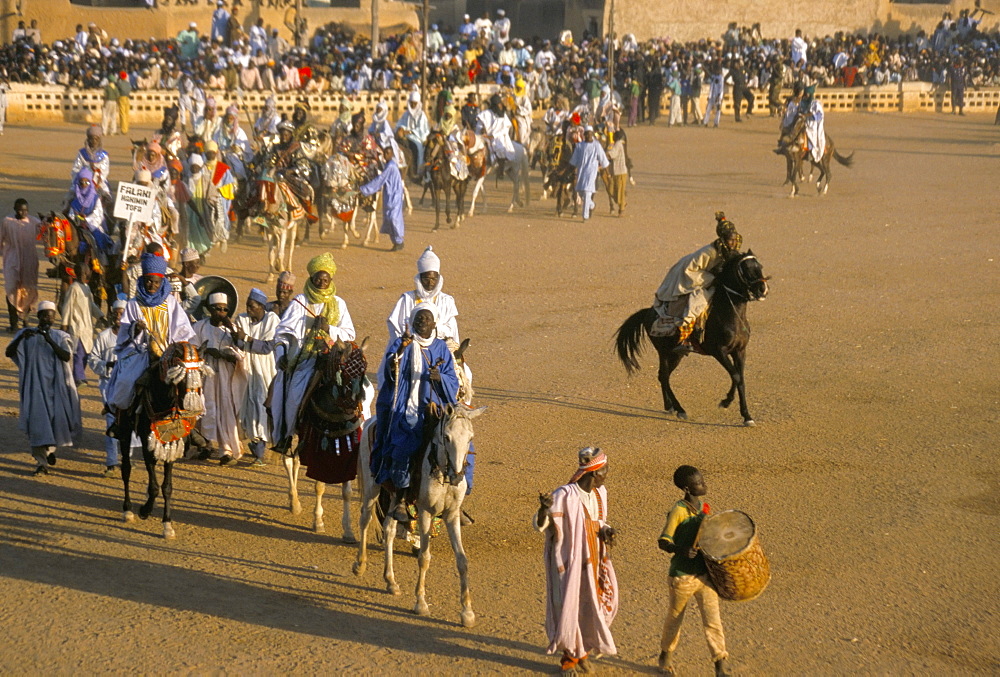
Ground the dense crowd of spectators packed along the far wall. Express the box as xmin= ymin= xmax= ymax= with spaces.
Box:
xmin=0 ymin=3 xmax=1000 ymax=101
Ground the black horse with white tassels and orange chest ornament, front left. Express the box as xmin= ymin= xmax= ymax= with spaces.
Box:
xmin=116 ymin=341 xmax=211 ymax=540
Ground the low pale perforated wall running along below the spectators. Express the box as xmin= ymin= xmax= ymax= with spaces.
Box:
xmin=7 ymin=82 xmax=1000 ymax=126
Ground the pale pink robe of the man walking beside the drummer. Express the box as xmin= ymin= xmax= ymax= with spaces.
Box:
xmin=533 ymin=483 xmax=618 ymax=659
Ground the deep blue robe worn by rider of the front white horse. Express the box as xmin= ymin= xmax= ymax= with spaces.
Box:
xmin=371 ymin=338 xmax=458 ymax=489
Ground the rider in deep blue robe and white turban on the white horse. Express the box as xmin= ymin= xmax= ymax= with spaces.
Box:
xmin=371 ymin=303 xmax=458 ymax=521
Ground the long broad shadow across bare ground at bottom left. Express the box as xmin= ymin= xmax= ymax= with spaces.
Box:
xmin=0 ymin=542 xmax=551 ymax=671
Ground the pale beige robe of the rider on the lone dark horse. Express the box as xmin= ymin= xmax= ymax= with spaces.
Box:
xmin=649 ymin=243 xmax=722 ymax=340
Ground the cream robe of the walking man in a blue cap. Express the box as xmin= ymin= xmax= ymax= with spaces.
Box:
xmin=236 ymin=312 xmax=280 ymax=442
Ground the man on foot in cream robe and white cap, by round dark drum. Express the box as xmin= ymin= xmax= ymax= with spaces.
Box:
xmin=192 ymin=292 xmax=247 ymax=465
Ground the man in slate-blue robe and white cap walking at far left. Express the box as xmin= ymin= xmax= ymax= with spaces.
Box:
xmin=6 ymin=301 xmax=82 ymax=475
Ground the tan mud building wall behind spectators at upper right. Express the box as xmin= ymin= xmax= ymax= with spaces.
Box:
xmin=604 ymin=0 xmax=1000 ymax=41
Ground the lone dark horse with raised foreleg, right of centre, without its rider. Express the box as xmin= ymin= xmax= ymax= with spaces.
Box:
xmin=615 ymin=250 xmax=769 ymax=427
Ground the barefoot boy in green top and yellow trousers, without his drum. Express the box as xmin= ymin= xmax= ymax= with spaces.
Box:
xmin=657 ymin=465 xmax=730 ymax=677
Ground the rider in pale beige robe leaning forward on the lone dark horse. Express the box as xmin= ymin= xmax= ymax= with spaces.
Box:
xmin=649 ymin=212 xmax=743 ymax=351
